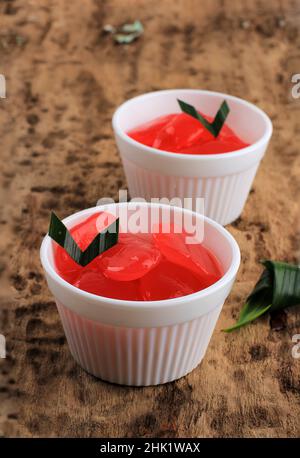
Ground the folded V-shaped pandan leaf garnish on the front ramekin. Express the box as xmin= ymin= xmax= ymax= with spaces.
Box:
xmin=48 ymin=212 xmax=119 ymax=266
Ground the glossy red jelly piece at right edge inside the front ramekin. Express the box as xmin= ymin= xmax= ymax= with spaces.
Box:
xmin=153 ymin=225 xmax=222 ymax=286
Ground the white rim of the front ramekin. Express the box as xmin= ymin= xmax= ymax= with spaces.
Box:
xmin=40 ymin=202 xmax=241 ymax=310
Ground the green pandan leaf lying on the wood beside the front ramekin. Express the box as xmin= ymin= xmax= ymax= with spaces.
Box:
xmin=224 ymin=260 xmax=300 ymax=332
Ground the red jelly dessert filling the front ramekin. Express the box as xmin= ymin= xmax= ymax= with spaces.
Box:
xmin=54 ymin=212 xmax=223 ymax=301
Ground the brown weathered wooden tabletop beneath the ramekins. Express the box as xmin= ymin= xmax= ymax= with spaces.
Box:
xmin=0 ymin=0 xmax=300 ymax=437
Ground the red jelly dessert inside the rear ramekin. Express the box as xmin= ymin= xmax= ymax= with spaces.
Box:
xmin=127 ymin=113 xmax=249 ymax=154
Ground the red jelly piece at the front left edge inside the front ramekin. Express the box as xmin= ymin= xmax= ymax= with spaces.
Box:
xmin=73 ymin=269 xmax=143 ymax=301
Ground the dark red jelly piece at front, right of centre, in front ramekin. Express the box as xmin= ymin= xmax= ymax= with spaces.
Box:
xmin=140 ymin=259 xmax=206 ymax=301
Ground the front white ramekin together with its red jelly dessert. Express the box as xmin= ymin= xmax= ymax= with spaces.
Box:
xmin=41 ymin=202 xmax=240 ymax=385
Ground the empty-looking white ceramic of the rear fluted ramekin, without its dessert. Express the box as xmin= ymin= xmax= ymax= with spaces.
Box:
xmin=113 ymin=89 xmax=272 ymax=225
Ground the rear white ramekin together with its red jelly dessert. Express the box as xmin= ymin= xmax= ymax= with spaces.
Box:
xmin=113 ymin=89 xmax=272 ymax=225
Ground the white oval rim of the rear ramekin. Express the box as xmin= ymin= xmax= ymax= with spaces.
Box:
xmin=112 ymin=88 xmax=273 ymax=161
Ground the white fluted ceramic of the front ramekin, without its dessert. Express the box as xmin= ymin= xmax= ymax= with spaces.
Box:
xmin=40 ymin=202 xmax=240 ymax=386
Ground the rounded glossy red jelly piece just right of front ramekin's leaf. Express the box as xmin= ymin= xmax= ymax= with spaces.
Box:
xmin=98 ymin=234 xmax=161 ymax=282
